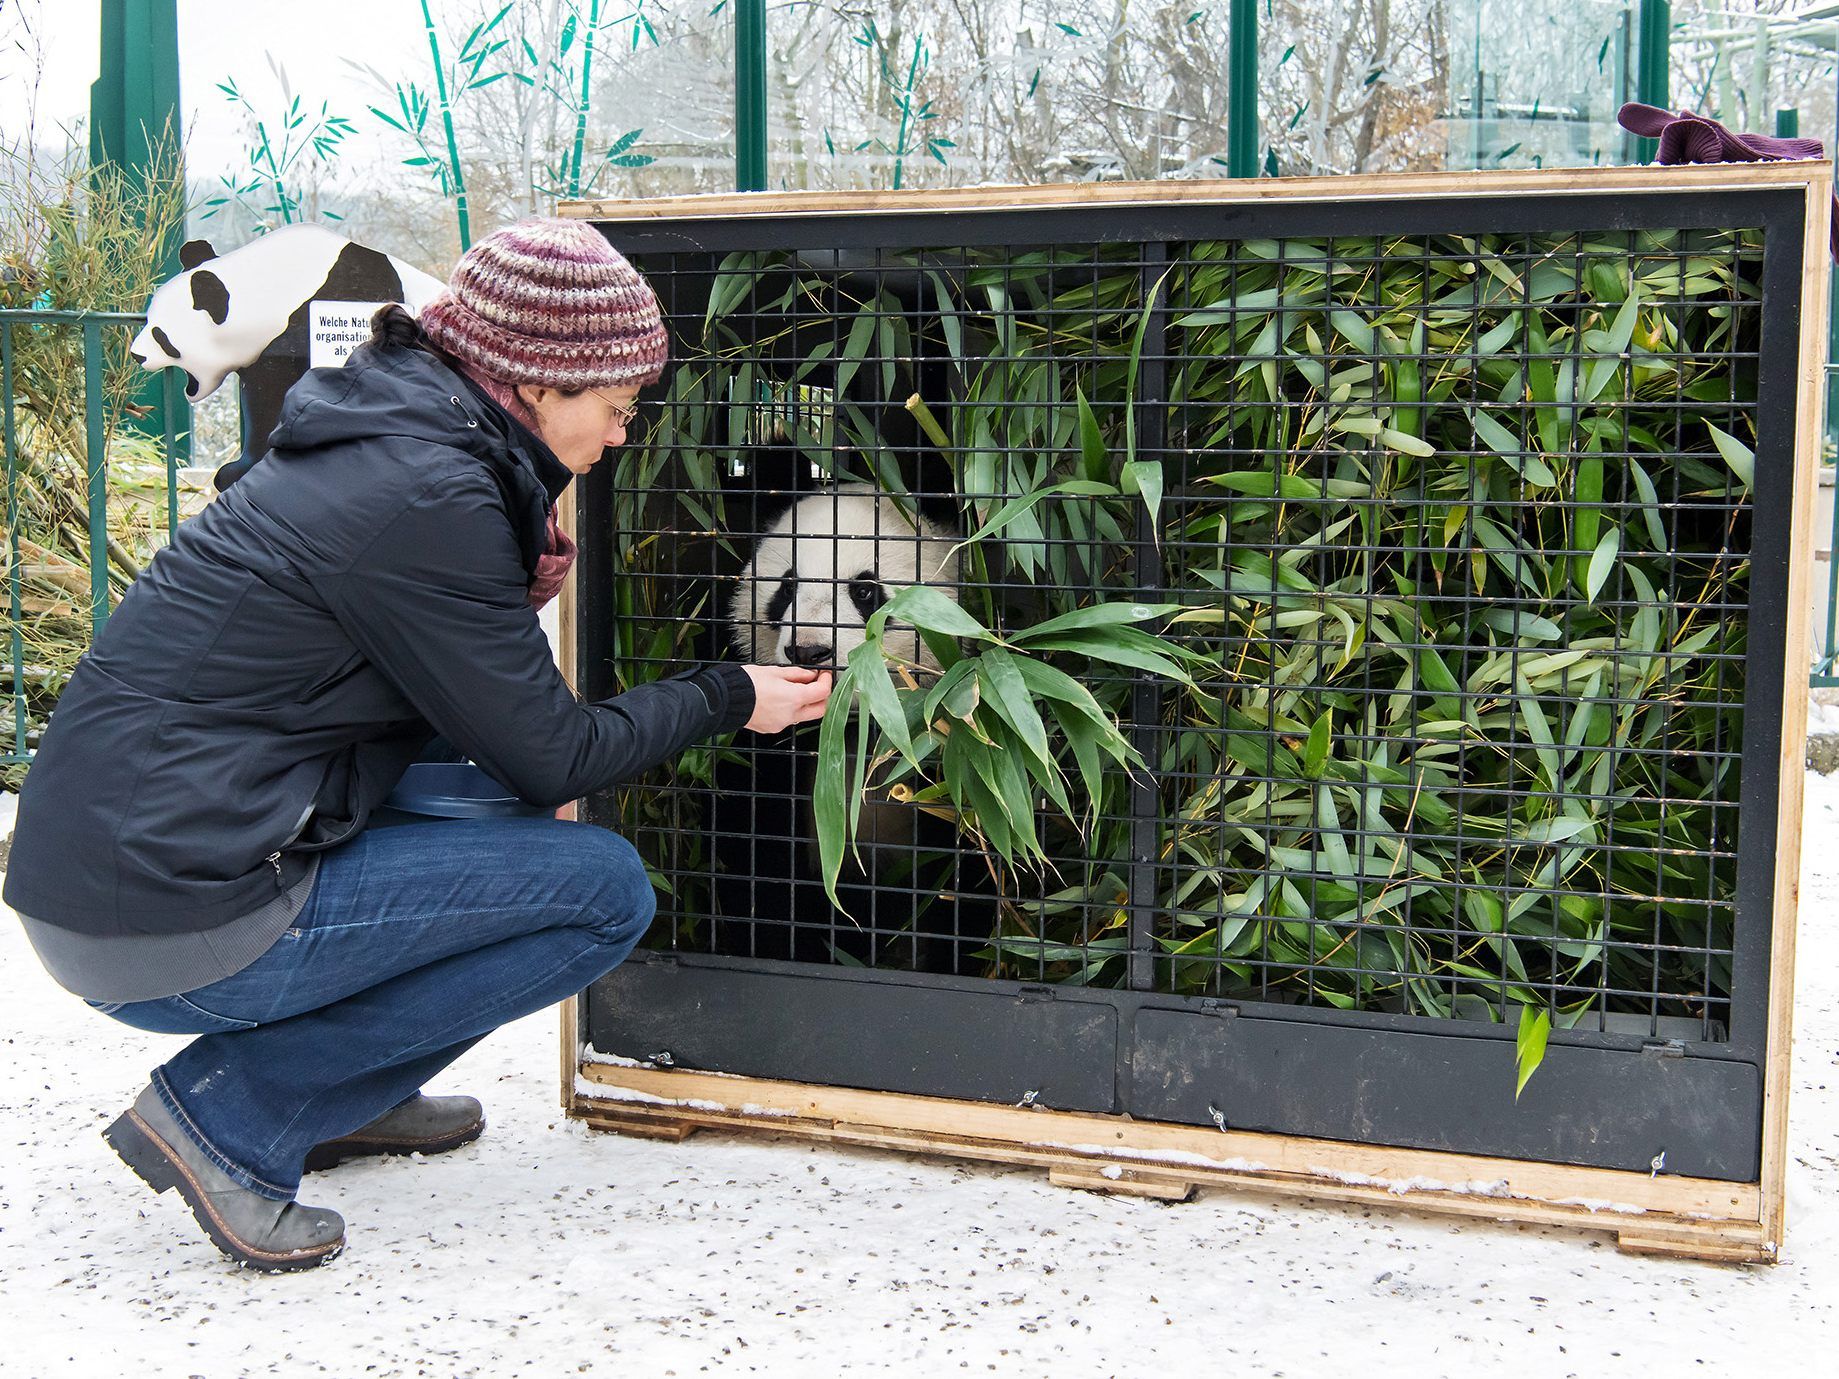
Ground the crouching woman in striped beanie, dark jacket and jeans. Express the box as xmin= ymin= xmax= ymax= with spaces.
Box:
xmin=6 ymin=221 xmax=829 ymax=1271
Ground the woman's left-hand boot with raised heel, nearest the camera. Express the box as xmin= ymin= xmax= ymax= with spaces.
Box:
xmin=103 ymin=1085 xmax=344 ymax=1274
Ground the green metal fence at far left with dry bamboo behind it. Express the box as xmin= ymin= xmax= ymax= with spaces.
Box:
xmin=0 ymin=309 xmax=186 ymax=770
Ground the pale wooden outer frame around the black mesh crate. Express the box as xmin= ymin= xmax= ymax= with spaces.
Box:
xmin=544 ymin=162 xmax=1833 ymax=1263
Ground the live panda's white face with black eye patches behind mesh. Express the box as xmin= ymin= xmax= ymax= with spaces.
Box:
xmin=730 ymin=484 xmax=958 ymax=669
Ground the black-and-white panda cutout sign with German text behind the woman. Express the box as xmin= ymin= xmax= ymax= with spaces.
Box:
xmin=131 ymin=224 xmax=445 ymax=489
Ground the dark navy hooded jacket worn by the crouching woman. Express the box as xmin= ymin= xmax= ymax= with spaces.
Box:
xmin=6 ymin=344 xmax=754 ymax=936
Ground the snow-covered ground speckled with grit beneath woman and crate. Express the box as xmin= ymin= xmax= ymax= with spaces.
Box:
xmin=0 ymin=776 xmax=1839 ymax=1379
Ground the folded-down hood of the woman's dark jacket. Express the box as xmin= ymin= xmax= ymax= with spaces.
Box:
xmin=268 ymin=344 xmax=574 ymax=506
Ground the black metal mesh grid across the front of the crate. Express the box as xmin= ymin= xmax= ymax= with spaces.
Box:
xmin=585 ymin=199 xmax=1762 ymax=1041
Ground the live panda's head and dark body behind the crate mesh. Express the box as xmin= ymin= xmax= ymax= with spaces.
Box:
xmin=708 ymin=484 xmax=995 ymax=974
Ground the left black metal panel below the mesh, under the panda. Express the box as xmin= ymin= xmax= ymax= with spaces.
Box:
xmin=588 ymin=954 xmax=1120 ymax=1112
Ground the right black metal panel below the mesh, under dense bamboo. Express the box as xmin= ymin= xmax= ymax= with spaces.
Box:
xmin=1131 ymin=1009 xmax=1762 ymax=1182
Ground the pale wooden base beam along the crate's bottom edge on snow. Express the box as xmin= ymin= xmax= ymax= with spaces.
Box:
xmin=563 ymin=1044 xmax=1776 ymax=1263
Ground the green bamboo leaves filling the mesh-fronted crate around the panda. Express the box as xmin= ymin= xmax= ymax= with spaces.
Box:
xmin=622 ymin=232 xmax=1760 ymax=1074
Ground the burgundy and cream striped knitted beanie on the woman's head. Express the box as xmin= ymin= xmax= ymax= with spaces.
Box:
xmin=417 ymin=219 xmax=669 ymax=393
